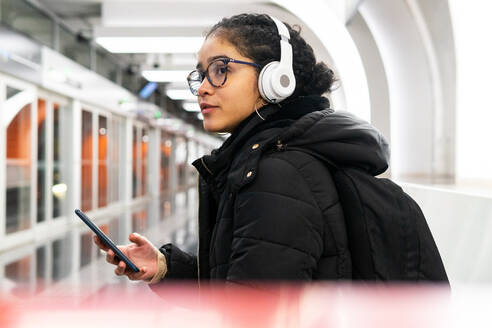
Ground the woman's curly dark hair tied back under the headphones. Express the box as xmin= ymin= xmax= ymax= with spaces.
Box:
xmin=206 ymin=14 xmax=336 ymax=100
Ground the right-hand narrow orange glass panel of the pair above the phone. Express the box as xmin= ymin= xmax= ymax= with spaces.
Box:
xmin=97 ymin=116 xmax=108 ymax=207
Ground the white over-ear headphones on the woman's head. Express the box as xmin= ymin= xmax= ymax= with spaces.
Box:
xmin=258 ymin=16 xmax=296 ymax=104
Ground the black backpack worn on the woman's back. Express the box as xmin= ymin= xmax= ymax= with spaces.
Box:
xmin=297 ymin=149 xmax=448 ymax=283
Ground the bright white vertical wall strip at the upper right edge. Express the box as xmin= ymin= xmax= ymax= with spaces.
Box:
xmin=449 ymin=0 xmax=492 ymax=183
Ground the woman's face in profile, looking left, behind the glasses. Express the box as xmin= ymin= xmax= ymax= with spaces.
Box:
xmin=197 ymin=35 xmax=260 ymax=132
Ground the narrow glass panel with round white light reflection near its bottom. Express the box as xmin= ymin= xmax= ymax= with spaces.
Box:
xmin=51 ymin=104 xmax=70 ymax=218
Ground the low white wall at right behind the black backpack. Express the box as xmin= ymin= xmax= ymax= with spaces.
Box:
xmin=401 ymin=184 xmax=492 ymax=283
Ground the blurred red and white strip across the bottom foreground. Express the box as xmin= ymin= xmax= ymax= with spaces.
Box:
xmin=0 ymin=284 xmax=492 ymax=328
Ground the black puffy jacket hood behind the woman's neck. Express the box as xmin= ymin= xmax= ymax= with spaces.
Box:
xmin=279 ymin=101 xmax=390 ymax=176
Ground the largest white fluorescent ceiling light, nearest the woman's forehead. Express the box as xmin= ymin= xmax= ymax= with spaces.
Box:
xmin=96 ymin=36 xmax=205 ymax=54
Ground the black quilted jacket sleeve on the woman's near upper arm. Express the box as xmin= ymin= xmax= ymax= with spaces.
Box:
xmin=227 ymin=155 xmax=323 ymax=282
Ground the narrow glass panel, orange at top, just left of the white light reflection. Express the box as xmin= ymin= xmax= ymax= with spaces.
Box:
xmin=36 ymin=99 xmax=46 ymax=222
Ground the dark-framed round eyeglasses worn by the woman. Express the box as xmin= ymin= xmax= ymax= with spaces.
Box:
xmin=187 ymin=58 xmax=261 ymax=96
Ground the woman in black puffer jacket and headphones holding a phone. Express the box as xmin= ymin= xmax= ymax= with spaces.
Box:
xmin=95 ymin=14 xmax=389 ymax=283
